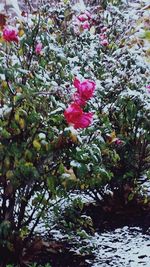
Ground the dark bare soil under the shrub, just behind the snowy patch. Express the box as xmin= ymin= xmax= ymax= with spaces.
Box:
xmin=84 ymin=198 xmax=150 ymax=232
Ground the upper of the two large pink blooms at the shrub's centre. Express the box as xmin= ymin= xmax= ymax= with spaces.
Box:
xmin=73 ymin=78 xmax=96 ymax=101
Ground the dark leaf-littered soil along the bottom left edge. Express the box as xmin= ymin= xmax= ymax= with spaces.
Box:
xmin=0 ymin=237 xmax=94 ymax=267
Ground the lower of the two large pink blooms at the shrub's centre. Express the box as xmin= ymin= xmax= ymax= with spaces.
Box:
xmin=64 ymin=103 xmax=93 ymax=129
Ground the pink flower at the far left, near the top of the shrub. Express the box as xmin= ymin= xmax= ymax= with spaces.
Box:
xmin=2 ymin=27 xmax=19 ymax=43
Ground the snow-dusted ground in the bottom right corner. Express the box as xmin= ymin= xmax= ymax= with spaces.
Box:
xmin=88 ymin=227 xmax=150 ymax=267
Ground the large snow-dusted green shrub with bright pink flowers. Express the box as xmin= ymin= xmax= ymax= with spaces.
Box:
xmin=0 ymin=1 xmax=149 ymax=261
